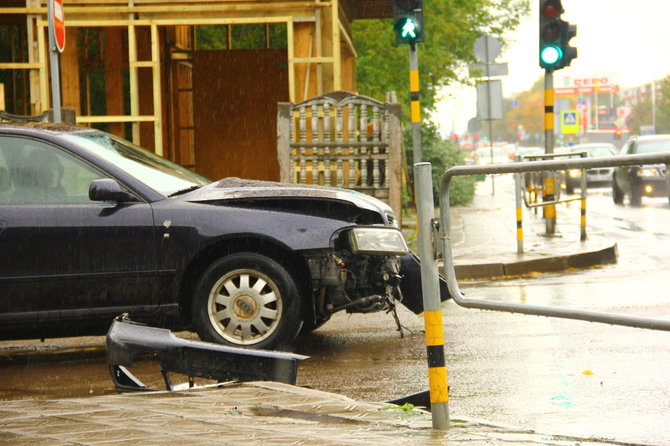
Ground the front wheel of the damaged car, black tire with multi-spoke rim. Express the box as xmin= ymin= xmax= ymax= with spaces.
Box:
xmin=192 ymin=252 xmax=302 ymax=350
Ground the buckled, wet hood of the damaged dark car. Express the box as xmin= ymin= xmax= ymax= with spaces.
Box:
xmin=184 ymin=178 xmax=393 ymax=215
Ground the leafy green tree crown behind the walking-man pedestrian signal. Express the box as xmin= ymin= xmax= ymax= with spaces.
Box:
xmin=352 ymin=0 xmax=529 ymax=121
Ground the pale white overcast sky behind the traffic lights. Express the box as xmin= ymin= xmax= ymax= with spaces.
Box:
xmin=434 ymin=0 xmax=670 ymax=134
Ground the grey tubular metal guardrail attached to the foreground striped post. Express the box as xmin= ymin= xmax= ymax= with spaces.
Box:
xmin=415 ymin=153 xmax=670 ymax=331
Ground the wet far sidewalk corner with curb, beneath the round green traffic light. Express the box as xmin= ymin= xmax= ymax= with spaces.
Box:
xmin=404 ymin=177 xmax=618 ymax=280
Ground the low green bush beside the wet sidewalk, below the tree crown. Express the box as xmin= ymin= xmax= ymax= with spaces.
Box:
xmin=405 ymin=122 xmax=475 ymax=206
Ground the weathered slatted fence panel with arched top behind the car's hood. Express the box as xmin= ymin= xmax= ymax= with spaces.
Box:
xmin=277 ymin=91 xmax=402 ymax=218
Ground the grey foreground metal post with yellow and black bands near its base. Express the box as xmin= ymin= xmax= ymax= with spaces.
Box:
xmin=414 ymin=163 xmax=449 ymax=429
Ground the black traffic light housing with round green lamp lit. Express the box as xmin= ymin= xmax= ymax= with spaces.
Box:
xmin=540 ymin=0 xmax=577 ymax=71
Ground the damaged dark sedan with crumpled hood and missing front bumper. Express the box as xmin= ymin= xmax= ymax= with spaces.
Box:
xmin=0 ymin=124 xmax=447 ymax=349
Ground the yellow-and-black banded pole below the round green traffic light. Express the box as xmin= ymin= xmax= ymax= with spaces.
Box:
xmin=542 ymin=70 xmax=556 ymax=235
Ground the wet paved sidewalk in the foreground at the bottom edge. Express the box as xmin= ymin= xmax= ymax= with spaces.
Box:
xmin=0 ymin=382 xmax=636 ymax=446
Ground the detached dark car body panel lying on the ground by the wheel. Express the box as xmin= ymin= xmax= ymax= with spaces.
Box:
xmin=107 ymin=317 xmax=308 ymax=391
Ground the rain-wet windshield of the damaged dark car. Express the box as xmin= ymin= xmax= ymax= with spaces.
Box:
xmin=64 ymin=132 xmax=211 ymax=196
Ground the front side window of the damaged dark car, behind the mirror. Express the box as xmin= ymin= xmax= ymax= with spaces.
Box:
xmin=0 ymin=137 xmax=106 ymax=204
